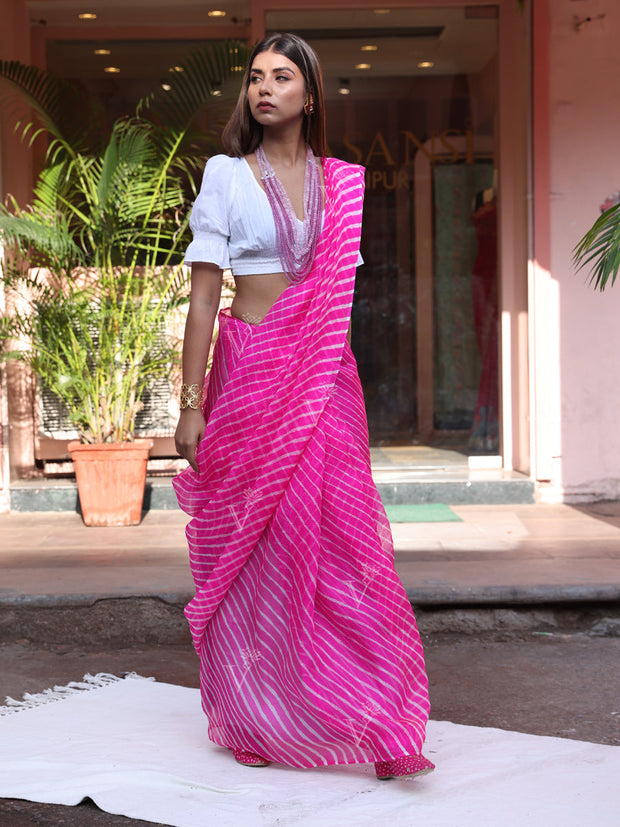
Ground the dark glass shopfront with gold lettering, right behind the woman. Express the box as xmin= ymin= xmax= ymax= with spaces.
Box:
xmin=266 ymin=6 xmax=499 ymax=454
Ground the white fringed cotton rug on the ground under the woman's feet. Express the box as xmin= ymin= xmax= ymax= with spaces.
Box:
xmin=0 ymin=675 xmax=620 ymax=827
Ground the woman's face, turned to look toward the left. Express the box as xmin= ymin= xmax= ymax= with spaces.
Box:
xmin=248 ymin=50 xmax=306 ymax=128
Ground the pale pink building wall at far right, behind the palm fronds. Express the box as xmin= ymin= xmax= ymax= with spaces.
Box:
xmin=538 ymin=0 xmax=620 ymax=501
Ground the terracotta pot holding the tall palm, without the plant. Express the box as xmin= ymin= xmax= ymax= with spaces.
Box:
xmin=68 ymin=439 xmax=153 ymax=526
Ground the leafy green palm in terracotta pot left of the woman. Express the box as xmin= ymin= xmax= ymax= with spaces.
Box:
xmin=0 ymin=43 xmax=247 ymax=525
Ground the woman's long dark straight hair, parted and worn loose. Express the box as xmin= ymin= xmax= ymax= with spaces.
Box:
xmin=222 ymin=33 xmax=328 ymax=158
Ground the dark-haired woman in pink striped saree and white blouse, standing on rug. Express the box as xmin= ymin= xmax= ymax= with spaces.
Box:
xmin=175 ymin=34 xmax=433 ymax=778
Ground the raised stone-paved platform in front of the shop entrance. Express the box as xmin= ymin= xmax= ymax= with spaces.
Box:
xmin=0 ymin=503 xmax=620 ymax=607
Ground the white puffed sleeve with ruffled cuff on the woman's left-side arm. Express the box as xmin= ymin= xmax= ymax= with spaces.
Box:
xmin=184 ymin=155 xmax=233 ymax=269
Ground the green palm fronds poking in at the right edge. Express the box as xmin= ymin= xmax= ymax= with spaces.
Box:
xmin=573 ymin=204 xmax=620 ymax=291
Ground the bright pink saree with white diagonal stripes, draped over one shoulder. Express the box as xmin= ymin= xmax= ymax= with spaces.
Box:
xmin=174 ymin=159 xmax=429 ymax=767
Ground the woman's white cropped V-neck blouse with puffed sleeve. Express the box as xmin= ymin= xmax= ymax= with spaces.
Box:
xmin=185 ymin=155 xmax=364 ymax=276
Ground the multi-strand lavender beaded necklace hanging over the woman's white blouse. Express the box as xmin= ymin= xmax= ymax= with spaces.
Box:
xmin=256 ymin=144 xmax=323 ymax=284
